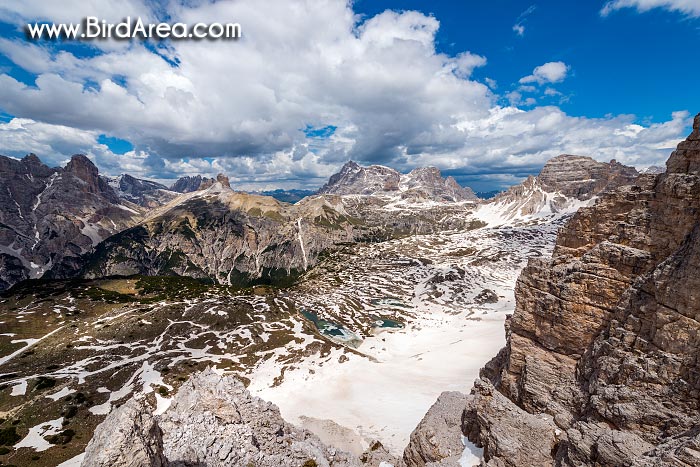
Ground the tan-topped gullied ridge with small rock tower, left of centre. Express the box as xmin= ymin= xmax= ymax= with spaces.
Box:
xmin=65 ymin=181 xmax=362 ymax=285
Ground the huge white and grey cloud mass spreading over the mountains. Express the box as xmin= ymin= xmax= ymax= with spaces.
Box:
xmin=0 ymin=0 xmax=689 ymax=189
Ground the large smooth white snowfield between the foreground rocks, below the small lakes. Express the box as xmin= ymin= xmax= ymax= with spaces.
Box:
xmin=249 ymin=312 xmax=505 ymax=454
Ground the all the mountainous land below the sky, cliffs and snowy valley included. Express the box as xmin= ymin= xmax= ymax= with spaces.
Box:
xmin=0 ymin=116 xmax=700 ymax=467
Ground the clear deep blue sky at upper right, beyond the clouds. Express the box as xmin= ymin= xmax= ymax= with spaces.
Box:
xmin=356 ymin=0 xmax=700 ymax=123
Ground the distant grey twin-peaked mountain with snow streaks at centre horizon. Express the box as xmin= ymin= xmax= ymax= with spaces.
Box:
xmin=318 ymin=161 xmax=477 ymax=202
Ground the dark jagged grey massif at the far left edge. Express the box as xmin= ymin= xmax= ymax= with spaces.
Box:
xmin=0 ymin=154 xmax=141 ymax=291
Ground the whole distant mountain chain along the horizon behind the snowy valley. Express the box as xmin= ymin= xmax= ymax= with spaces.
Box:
xmin=0 ymin=154 xmax=637 ymax=290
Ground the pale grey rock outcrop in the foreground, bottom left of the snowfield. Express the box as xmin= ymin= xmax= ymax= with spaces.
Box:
xmin=82 ymin=370 xmax=360 ymax=467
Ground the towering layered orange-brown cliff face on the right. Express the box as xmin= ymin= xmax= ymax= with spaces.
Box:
xmin=462 ymin=115 xmax=700 ymax=466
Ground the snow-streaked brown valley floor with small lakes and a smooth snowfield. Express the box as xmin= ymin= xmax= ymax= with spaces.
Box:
xmin=0 ymin=221 xmax=559 ymax=466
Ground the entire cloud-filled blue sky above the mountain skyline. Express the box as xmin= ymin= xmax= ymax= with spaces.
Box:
xmin=0 ymin=0 xmax=700 ymax=190
